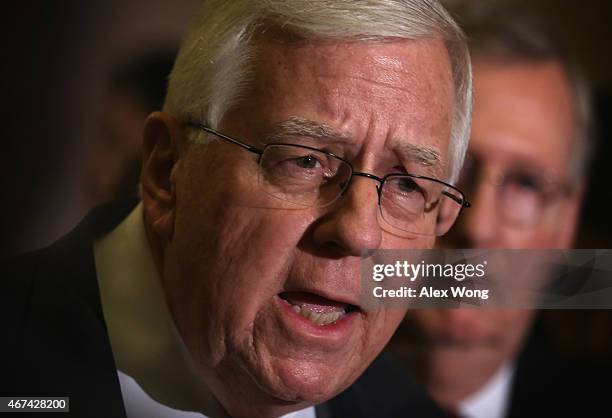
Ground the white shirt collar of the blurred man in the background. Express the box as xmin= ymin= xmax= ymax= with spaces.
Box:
xmin=459 ymin=364 xmax=515 ymax=418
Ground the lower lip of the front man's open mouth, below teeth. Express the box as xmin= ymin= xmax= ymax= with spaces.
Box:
xmin=275 ymin=296 xmax=360 ymax=345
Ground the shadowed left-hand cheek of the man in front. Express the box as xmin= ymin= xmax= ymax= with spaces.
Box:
xmin=167 ymin=194 xmax=311 ymax=364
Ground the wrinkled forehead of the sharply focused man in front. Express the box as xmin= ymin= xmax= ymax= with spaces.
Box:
xmin=230 ymin=34 xmax=454 ymax=167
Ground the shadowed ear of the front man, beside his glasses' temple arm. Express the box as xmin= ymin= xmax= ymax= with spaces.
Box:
xmin=141 ymin=112 xmax=182 ymax=244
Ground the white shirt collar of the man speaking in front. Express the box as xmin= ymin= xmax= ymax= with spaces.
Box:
xmin=94 ymin=204 xmax=315 ymax=418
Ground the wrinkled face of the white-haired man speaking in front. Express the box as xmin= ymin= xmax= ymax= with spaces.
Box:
xmin=158 ymin=36 xmax=454 ymax=407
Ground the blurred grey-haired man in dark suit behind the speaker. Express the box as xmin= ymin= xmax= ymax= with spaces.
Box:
xmin=395 ymin=9 xmax=609 ymax=418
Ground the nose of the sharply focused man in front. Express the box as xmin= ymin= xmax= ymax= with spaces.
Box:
xmin=313 ymin=177 xmax=382 ymax=257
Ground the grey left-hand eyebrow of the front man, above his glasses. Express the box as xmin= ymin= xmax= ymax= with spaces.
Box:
xmin=266 ymin=116 xmax=351 ymax=142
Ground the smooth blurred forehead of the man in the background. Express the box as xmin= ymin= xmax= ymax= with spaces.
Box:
xmin=470 ymin=59 xmax=576 ymax=175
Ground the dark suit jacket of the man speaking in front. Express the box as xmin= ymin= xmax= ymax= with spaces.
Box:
xmin=0 ymin=201 xmax=443 ymax=418
